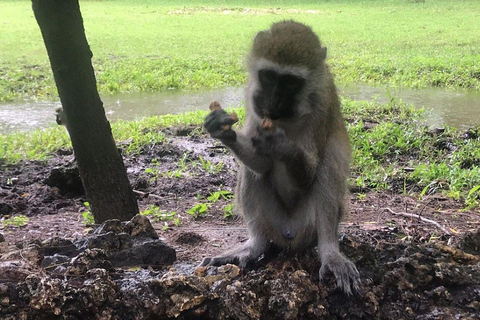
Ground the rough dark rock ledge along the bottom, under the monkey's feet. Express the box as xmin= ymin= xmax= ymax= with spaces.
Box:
xmin=0 ymin=238 xmax=480 ymax=320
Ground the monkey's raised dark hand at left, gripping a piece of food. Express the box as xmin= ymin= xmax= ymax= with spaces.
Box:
xmin=203 ymin=109 xmax=237 ymax=143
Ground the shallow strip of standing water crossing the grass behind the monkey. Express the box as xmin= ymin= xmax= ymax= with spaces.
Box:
xmin=0 ymin=86 xmax=480 ymax=133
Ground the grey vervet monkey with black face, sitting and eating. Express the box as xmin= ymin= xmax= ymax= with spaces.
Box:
xmin=202 ymin=21 xmax=360 ymax=294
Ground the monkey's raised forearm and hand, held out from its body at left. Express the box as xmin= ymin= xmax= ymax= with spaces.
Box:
xmin=204 ymin=109 xmax=273 ymax=175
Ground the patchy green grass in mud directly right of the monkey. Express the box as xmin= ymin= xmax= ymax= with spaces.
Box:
xmin=343 ymin=99 xmax=480 ymax=207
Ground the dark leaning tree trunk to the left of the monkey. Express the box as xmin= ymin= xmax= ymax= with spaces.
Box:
xmin=32 ymin=0 xmax=138 ymax=223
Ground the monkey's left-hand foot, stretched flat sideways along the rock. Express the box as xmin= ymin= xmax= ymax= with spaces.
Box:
xmin=200 ymin=237 xmax=267 ymax=268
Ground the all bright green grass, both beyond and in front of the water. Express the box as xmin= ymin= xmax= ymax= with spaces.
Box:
xmin=0 ymin=0 xmax=480 ymax=207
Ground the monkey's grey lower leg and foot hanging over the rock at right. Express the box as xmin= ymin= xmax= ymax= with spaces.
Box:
xmin=317 ymin=203 xmax=360 ymax=295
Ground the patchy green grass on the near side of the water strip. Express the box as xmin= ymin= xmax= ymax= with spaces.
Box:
xmin=0 ymin=99 xmax=480 ymax=207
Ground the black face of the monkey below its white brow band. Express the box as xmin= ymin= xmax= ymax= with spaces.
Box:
xmin=253 ymin=69 xmax=305 ymax=120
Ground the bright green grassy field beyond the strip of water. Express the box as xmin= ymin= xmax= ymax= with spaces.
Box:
xmin=0 ymin=0 xmax=480 ymax=101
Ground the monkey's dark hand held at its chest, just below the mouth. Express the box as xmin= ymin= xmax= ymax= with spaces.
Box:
xmin=252 ymin=126 xmax=288 ymax=156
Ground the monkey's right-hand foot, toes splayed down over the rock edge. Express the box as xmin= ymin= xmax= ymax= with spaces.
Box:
xmin=319 ymin=252 xmax=361 ymax=295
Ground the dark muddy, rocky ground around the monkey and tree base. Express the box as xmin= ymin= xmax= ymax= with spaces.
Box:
xmin=0 ymin=128 xmax=480 ymax=319
